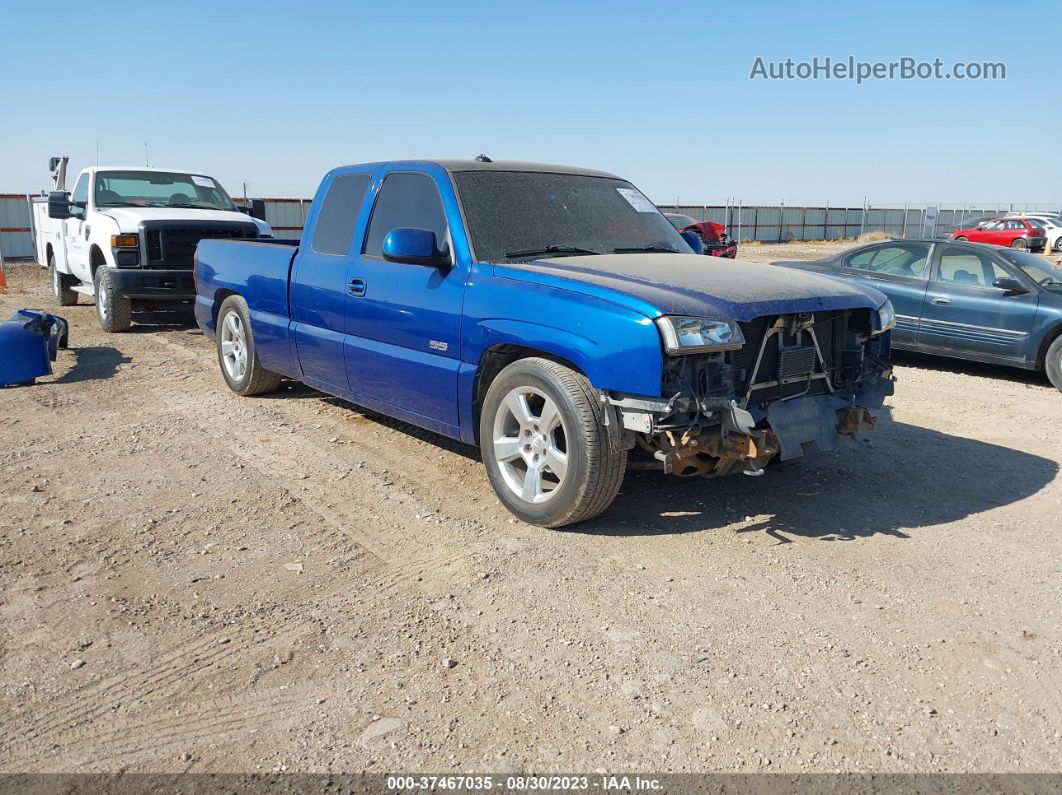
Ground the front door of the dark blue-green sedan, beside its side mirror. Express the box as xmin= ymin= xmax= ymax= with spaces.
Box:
xmin=919 ymin=244 xmax=1038 ymax=360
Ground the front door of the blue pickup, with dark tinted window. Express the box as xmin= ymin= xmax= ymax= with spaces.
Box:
xmin=345 ymin=169 xmax=468 ymax=432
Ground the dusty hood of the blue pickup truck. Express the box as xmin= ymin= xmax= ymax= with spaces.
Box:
xmin=495 ymin=254 xmax=886 ymax=322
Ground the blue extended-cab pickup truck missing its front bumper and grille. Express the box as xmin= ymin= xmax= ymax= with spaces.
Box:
xmin=194 ymin=157 xmax=894 ymax=528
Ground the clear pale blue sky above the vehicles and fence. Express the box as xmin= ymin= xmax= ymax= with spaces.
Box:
xmin=0 ymin=0 xmax=1062 ymax=204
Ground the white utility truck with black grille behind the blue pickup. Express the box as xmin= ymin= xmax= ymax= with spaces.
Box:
xmin=34 ymin=158 xmax=273 ymax=331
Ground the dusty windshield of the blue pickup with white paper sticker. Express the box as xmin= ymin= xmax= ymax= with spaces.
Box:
xmin=453 ymin=171 xmax=692 ymax=262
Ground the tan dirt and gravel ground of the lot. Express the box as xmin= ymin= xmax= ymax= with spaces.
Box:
xmin=0 ymin=244 xmax=1062 ymax=773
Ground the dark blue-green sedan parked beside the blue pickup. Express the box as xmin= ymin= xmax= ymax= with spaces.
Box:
xmin=772 ymin=240 xmax=1062 ymax=390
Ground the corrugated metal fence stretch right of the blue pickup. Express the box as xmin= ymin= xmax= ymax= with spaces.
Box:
xmin=660 ymin=203 xmax=1062 ymax=243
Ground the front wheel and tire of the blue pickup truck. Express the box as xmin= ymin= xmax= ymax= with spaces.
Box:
xmin=479 ymin=358 xmax=627 ymax=528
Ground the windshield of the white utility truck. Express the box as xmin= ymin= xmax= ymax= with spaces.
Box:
xmin=96 ymin=171 xmax=236 ymax=210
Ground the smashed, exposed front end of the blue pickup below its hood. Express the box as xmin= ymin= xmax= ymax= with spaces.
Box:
xmin=602 ymin=304 xmax=893 ymax=477
